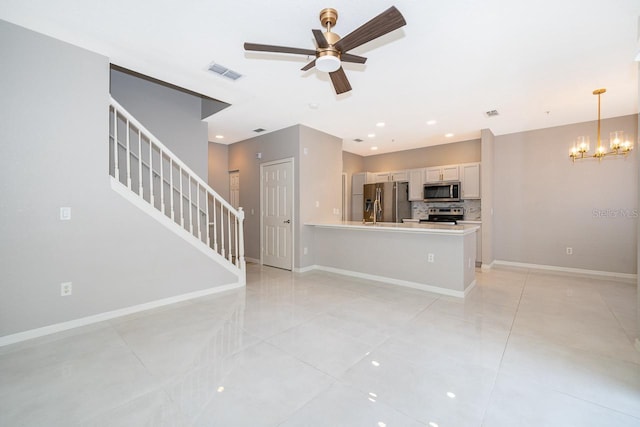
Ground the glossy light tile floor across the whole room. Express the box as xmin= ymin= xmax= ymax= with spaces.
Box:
xmin=0 ymin=264 xmax=640 ymax=427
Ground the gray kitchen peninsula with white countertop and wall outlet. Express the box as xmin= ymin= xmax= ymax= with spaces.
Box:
xmin=305 ymin=221 xmax=478 ymax=297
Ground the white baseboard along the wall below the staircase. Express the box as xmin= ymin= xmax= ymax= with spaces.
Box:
xmin=0 ymin=282 xmax=244 ymax=347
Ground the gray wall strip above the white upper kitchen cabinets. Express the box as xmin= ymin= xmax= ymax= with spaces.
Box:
xmin=364 ymin=139 xmax=480 ymax=172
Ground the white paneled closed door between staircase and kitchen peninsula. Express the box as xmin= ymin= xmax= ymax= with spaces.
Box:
xmin=261 ymin=160 xmax=293 ymax=270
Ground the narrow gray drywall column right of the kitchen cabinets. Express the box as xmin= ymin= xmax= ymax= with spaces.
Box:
xmin=480 ymin=129 xmax=495 ymax=269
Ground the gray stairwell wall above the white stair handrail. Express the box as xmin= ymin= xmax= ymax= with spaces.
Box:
xmin=110 ymin=69 xmax=208 ymax=182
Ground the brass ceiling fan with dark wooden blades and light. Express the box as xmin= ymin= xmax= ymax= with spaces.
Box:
xmin=244 ymin=6 xmax=407 ymax=95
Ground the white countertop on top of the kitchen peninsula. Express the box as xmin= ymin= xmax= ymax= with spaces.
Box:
xmin=304 ymin=221 xmax=478 ymax=235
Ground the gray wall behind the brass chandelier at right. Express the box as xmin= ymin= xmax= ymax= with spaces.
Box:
xmin=492 ymin=115 xmax=638 ymax=274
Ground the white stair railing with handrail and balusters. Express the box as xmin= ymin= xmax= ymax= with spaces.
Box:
xmin=109 ymin=97 xmax=246 ymax=278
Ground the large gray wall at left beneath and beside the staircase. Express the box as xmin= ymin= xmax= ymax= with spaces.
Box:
xmin=0 ymin=21 xmax=235 ymax=336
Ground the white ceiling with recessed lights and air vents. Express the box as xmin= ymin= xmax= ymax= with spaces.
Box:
xmin=0 ymin=0 xmax=640 ymax=156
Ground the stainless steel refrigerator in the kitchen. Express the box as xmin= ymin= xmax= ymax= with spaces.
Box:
xmin=362 ymin=182 xmax=411 ymax=222
